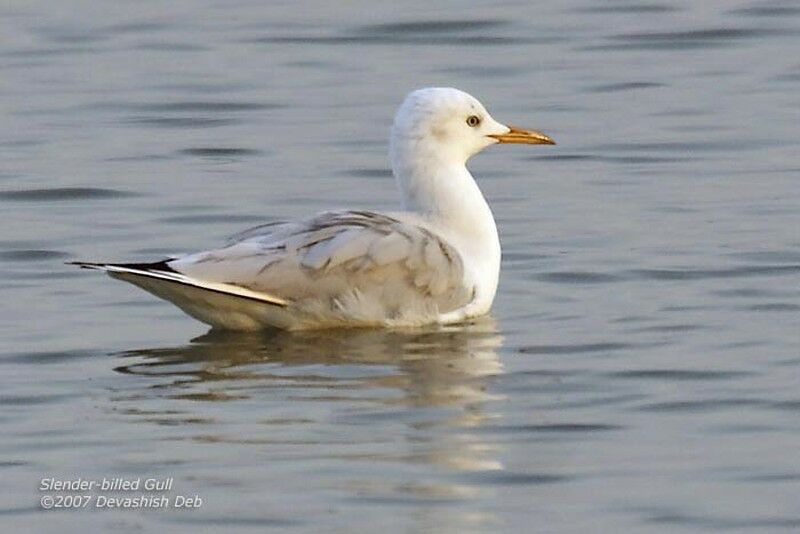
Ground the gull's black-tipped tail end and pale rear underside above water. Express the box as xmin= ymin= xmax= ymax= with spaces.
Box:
xmin=69 ymin=259 xmax=298 ymax=330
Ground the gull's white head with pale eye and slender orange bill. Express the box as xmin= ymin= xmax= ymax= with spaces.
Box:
xmin=391 ymin=87 xmax=555 ymax=169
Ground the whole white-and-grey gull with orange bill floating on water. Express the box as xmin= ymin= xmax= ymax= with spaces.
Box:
xmin=75 ymin=87 xmax=555 ymax=330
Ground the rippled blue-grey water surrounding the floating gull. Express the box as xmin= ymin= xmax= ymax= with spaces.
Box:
xmin=0 ymin=0 xmax=800 ymax=532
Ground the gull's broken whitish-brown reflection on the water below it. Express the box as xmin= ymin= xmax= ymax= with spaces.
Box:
xmin=116 ymin=319 xmax=502 ymax=471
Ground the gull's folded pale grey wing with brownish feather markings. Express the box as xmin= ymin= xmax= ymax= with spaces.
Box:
xmin=170 ymin=211 xmax=472 ymax=315
